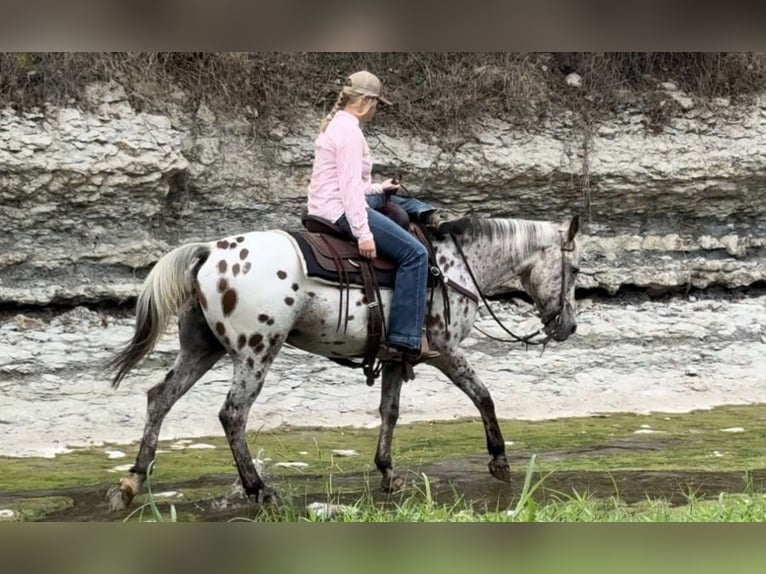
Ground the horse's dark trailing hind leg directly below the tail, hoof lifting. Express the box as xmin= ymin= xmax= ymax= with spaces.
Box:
xmin=108 ymin=305 xmax=225 ymax=510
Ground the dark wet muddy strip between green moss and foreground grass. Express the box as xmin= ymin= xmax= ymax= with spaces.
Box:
xmin=6 ymin=452 xmax=766 ymax=522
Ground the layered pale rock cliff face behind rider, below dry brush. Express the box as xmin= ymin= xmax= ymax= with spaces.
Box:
xmin=0 ymin=84 xmax=766 ymax=305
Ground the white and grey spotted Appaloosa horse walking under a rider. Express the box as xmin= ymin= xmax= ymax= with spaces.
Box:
xmin=103 ymin=216 xmax=579 ymax=510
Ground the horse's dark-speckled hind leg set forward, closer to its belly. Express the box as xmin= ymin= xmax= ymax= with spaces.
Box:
xmin=218 ymin=335 xmax=284 ymax=503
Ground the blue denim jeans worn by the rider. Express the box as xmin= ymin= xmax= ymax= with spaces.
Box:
xmin=336 ymin=209 xmax=428 ymax=351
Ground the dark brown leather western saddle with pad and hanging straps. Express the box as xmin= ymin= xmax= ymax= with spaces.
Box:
xmin=290 ymin=214 xmax=447 ymax=385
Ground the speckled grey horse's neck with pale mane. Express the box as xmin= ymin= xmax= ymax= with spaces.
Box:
xmin=461 ymin=219 xmax=558 ymax=291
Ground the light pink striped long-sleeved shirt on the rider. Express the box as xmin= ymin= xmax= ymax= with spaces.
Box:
xmin=308 ymin=110 xmax=383 ymax=242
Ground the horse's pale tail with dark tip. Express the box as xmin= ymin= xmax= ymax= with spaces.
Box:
xmin=106 ymin=243 xmax=210 ymax=388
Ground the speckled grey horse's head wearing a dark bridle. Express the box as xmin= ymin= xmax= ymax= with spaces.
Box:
xmin=519 ymin=216 xmax=580 ymax=341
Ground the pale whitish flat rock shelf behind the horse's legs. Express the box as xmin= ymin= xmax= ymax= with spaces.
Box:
xmin=0 ymin=289 xmax=766 ymax=462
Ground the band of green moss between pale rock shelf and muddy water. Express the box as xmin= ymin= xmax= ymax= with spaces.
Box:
xmin=0 ymin=405 xmax=766 ymax=500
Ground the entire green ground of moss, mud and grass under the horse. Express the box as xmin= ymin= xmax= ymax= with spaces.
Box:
xmin=0 ymin=405 xmax=766 ymax=521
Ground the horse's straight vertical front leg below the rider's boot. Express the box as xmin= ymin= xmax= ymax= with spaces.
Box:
xmin=375 ymin=363 xmax=404 ymax=492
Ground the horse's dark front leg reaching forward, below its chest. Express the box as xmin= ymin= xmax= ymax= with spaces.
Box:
xmin=431 ymin=347 xmax=511 ymax=482
